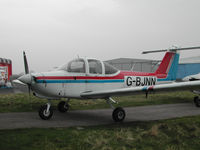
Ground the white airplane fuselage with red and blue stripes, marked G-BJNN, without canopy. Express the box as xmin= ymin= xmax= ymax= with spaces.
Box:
xmin=32 ymin=70 xmax=171 ymax=98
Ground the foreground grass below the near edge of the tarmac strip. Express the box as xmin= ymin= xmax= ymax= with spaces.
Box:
xmin=0 ymin=116 xmax=200 ymax=150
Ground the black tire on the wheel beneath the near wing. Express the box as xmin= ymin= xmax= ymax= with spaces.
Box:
xmin=112 ymin=107 xmax=126 ymax=122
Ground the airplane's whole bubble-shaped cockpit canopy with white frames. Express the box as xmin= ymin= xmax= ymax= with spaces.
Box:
xmin=58 ymin=58 xmax=118 ymax=75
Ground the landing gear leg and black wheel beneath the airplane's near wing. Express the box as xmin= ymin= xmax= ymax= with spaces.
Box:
xmin=106 ymin=97 xmax=126 ymax=122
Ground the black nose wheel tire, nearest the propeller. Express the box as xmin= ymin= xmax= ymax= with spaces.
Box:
xmin=38 ymin=105 xmax=53 ymax=120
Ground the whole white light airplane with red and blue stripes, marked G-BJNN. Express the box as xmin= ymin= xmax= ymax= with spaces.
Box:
xmin=17 ymin=47 xmax=200 ymax=122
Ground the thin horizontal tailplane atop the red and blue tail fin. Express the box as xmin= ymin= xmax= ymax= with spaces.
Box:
xmin=142 ymin=47 xmax=200 ymax=54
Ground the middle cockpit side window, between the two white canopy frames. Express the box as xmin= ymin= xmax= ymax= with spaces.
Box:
xmin=88 ymin=59 xmax=102 ymax=74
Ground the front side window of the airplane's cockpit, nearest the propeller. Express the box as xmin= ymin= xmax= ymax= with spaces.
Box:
xmin=67 ymin=59 xmax=85 ymax=73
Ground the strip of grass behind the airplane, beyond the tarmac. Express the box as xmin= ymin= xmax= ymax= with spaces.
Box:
xmin=0 ymin=92 xmax=197 ymax=112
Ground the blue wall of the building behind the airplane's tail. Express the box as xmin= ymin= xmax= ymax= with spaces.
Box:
xmin=176 ymin=63 xmax=200 ymax=79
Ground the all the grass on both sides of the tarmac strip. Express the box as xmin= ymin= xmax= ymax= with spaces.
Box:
xmin=0 ymin=92 xmax=200 ymax=150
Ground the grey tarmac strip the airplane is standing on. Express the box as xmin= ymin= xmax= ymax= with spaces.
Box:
xmin=0 ymin=103 xmax=200 ymax=129
